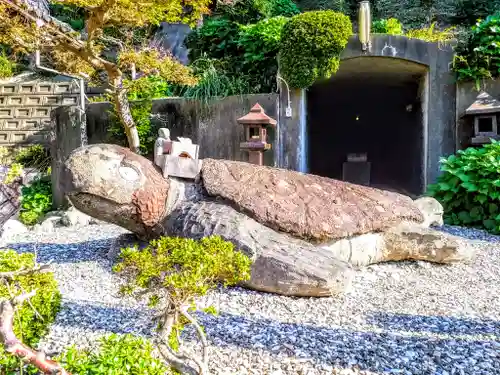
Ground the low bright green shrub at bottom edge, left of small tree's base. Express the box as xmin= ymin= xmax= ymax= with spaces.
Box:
xmin=57 ymin=334 xmax=173 ymax=375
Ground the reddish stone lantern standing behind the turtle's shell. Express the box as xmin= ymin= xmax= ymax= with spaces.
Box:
xmin=237 ymin=103 xmax=276 ymax=165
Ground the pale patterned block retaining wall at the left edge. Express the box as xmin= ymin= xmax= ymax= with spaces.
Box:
xmin=0 ymin=73 xmax=78 ymax=146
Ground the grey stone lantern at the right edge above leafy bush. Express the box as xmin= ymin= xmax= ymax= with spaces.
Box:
xmin=465 ymin=91 xmax=500 ymax=145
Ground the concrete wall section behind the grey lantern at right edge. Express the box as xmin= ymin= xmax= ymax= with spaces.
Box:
xmin=455 ymin=80 xmax=500 ymax=150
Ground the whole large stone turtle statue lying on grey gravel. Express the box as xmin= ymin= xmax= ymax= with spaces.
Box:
xmin=61 ymin=144 xmax=471 ymax=296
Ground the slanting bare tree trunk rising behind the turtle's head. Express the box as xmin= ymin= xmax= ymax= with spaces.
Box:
xmin=108 ymin=71 xmax=140 ymax=153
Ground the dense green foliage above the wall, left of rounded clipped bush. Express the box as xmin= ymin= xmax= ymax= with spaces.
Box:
xmin=184 ymin=0 xmax=299 ymax=95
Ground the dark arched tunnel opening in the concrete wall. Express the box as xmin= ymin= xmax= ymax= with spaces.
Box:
xmin=306 ymin=57 xmax=428 ymax=196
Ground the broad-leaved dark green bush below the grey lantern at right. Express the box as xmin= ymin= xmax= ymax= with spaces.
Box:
xmin=428 ymin=141 xmax=500 ymax=233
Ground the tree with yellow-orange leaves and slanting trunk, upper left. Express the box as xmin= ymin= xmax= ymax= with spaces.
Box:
xmin=0 ymin=0 xmax=210 ymax=151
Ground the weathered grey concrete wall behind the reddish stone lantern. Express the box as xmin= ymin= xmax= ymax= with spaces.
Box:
xmin=86 ymin=94 xmax=278 ymax=165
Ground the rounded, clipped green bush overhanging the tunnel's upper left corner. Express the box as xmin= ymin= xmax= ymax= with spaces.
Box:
xmin=279 ymin=10 xmax=352 ymax=88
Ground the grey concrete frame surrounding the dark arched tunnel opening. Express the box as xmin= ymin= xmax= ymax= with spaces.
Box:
xmin=279 ymin=34 xmax=456 ymax=189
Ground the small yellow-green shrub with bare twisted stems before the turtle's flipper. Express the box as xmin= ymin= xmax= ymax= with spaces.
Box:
xmin=113 ymin=236 xmax=251 ymax=372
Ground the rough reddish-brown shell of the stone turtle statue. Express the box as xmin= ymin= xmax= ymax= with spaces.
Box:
xmin=201 ymin=159 xmax=424 ymax=242
